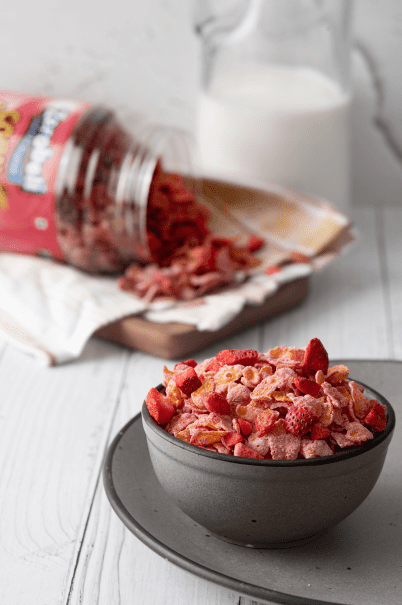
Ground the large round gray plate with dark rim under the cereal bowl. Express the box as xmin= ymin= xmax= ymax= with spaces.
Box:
xmin=104 ymin=361 xmax=402 ymax=605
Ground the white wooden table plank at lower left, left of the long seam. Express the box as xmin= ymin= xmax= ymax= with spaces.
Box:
xmin=0 ymin=341 xmax=128 ymax=605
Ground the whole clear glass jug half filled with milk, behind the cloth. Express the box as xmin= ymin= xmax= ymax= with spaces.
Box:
xmin=194 ymin=0 xmax=352 ymax=210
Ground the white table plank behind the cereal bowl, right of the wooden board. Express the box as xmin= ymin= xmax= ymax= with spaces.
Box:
xmin=263 ymin=209 xmax=392 ymax=359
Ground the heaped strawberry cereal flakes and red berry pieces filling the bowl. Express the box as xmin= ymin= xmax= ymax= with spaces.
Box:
xmin=146 ymin=338 xmax=386 ymax=460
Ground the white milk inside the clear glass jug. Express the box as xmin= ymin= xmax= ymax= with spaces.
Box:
xmin=197 ymin=65 xmax=350 ymax=211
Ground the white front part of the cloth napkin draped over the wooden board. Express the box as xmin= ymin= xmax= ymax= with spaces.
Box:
xmin=0 ymin=253 xmax=313 ymax=365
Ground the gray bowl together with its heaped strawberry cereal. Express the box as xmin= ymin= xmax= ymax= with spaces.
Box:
xmin=142 ymin=338 xmax=395 ymax=548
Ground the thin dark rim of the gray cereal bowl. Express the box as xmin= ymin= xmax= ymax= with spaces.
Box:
xmin=141 ymin=378 xmax=395 ymax=467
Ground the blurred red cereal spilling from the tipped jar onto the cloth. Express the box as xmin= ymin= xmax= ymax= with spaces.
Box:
xmin=118 ymin=164 xmax=264 ymax=303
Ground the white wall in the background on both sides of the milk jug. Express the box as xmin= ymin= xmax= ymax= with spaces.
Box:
xmin=0 ymin=0 xmax=402 ymax=206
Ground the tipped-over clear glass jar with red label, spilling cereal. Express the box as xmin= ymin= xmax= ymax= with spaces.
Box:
xmin=0 ymin=93 xmax=203 ymax=274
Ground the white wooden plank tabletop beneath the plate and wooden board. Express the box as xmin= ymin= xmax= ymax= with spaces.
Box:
xmin=0 ymin=208 xmax=402 ymax=605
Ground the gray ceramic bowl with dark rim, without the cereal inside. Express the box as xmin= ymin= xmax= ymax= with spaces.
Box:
xmin=142 ymin=385 xmax=395 ymax=548
